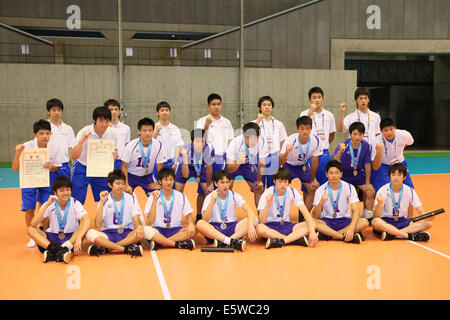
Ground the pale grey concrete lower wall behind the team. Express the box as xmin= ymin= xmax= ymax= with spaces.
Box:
xmin=0 ymin=64 xmax=356 ymax=161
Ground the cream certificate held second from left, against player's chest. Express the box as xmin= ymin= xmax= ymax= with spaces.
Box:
xmin=86 ymin=139 xmax=114 ymax=178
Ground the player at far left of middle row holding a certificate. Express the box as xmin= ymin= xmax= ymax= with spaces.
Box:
xmin=12 ymin=120 xmax=63 ymax=248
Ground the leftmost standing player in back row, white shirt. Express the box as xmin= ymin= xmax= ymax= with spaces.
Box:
xmin=47 ymin=98 xmax=75 ymax=178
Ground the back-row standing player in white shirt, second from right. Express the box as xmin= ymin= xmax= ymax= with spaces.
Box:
xmin=300 ymin=87 xmax=336 ymax=185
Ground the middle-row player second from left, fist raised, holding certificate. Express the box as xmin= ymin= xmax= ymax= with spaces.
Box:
xmin=71 ymin=107 xmax=119 ymax=204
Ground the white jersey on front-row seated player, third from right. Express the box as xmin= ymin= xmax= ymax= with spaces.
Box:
xmin=258 ymin=186 xmax=303 ymax=222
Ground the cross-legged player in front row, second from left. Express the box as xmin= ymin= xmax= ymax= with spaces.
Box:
xmin=86 ymin=169 xmax=145 ymax=257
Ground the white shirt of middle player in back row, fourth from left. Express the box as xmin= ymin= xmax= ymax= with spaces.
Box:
xmin=196 ymin=114 xmax=234 ymax=156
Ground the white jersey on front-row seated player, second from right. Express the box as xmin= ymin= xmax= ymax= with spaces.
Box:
xmin=313 ymin=180 xmax=359 ymax=218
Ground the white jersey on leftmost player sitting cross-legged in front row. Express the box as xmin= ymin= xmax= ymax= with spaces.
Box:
xmin=43 ymin=197 xmax=87 ymax=233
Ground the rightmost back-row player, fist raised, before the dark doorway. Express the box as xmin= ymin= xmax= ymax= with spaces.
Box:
xmin=338 ymin=88 xmax=381 ymax=144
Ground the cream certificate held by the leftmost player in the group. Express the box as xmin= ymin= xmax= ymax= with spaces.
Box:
xmin=19 ymin=148 xmax=50 ymax=189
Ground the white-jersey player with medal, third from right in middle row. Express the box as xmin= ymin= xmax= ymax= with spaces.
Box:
xmin=280 ymin=116 xmax=322 ymax=211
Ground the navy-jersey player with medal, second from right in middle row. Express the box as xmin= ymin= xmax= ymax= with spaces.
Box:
xmin=333 ymin=122 xmax=375 ymax=219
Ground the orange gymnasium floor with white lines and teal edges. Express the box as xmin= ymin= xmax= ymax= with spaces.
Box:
xmin=0 ymin=157 xmax=450 ymax=300
